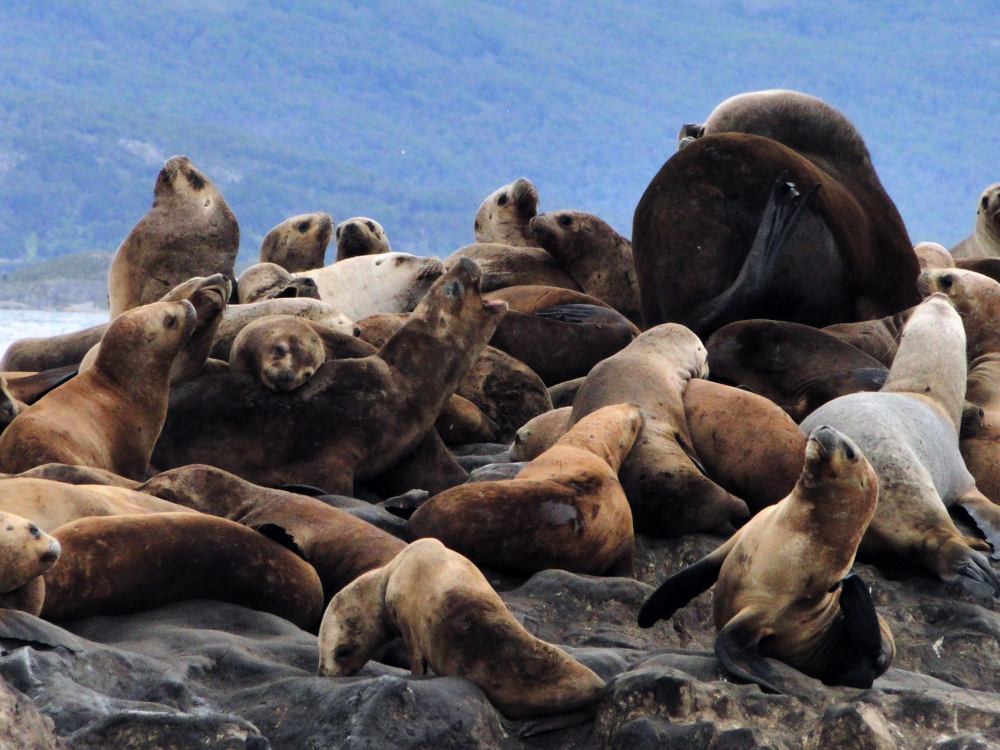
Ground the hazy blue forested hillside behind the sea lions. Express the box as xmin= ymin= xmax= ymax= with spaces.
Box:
xmin=0 ymin=0 xmax=1000 ymax=269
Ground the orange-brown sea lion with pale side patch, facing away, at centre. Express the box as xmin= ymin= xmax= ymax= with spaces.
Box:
xmin=406 ymin=404 xmax=642 ymax=576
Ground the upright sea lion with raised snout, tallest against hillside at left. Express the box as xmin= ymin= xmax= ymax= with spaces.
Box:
xmin=108 ymin=156 xmax=240 ymax=320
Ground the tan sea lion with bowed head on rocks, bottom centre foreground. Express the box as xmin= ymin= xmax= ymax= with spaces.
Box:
xmin=319 ymin=539 xmax=604 ymax=719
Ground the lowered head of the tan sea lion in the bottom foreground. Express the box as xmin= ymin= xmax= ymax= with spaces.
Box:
xmin=317 ymin=568 xmax=393 ymax=677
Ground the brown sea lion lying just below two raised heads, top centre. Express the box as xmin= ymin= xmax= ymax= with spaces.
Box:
xmin=444 ymin=243 xmax=583 ymax=292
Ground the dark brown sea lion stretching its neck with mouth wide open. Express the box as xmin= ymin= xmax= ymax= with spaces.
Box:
xmin=154 ymin=258 xmax=507 ymax=495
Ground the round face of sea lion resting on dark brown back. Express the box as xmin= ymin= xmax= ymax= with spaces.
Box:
xmin=229 ymin=315 xmax=326 ymax=392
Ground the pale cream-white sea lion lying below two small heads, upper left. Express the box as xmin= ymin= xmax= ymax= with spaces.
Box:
xmin=297 ymin=253 xmax=445 ymax=320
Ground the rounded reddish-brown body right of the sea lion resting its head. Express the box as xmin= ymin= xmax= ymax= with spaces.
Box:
xmin=684 ymin=382 xmax=806 ymax=513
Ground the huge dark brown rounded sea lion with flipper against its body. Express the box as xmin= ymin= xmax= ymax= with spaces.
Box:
xmin=632 ymin=129 xmax=919 ymax=337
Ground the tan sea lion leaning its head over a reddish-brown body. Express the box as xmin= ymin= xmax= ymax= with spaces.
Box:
xmin=570 ymin=326 xmax=750 ymax=537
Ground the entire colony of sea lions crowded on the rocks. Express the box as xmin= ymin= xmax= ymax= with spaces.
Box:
xmin=0 ymin=92 xmax=1000 ymax=748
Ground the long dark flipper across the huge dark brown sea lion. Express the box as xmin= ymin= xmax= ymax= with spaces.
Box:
xmin=691 ymin=172 xmax=819 ymax=339
